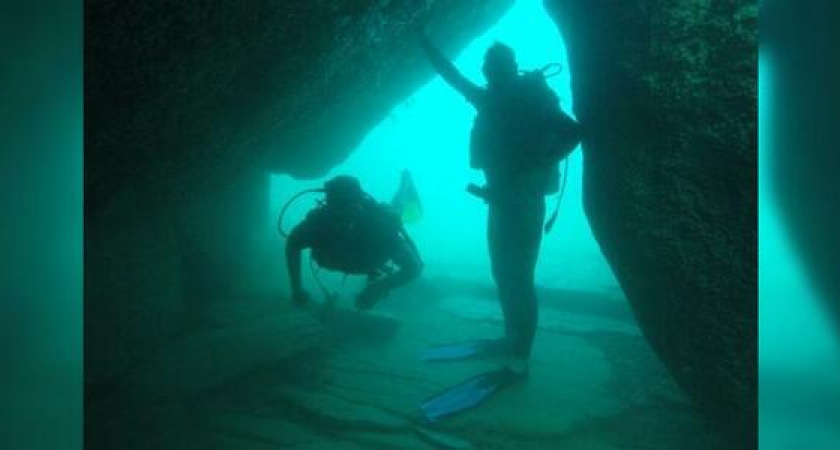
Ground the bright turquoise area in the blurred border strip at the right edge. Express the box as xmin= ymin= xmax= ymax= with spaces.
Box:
xmin=759 ymin=49 xmax=840 ymax=450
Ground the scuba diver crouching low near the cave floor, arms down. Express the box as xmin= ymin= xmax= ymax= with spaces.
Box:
xmin=278 ymin=176 xmax=423 ymax=310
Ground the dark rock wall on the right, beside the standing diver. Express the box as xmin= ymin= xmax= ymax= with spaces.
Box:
xmin=546 ymin=0 xmax=758 ymax=448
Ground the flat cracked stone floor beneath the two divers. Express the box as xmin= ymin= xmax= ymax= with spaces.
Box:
xmin=135 ymin=286 xmax=718 ymax=450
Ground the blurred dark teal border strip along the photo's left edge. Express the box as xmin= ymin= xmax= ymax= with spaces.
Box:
xmin=0 ymin=2 xmax=83 ymax=449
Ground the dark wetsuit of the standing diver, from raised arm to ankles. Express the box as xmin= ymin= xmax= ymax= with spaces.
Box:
xmin=425 ymin=38 xmax=579 ymax=359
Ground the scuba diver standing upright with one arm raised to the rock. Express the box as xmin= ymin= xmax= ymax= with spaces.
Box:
xmin=421 ymin=35 xmax=581 ymax=421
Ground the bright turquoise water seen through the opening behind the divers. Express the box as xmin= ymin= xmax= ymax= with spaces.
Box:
xmin=270 ymin=0 xmax=618 ymax=298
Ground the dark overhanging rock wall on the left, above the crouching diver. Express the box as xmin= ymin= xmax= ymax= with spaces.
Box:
xmin=85 ymin=0 xmax=512 ymax=386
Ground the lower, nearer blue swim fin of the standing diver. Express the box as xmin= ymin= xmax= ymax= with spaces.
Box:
xmin=420 ymin=367 xmax=526 ymax=422
